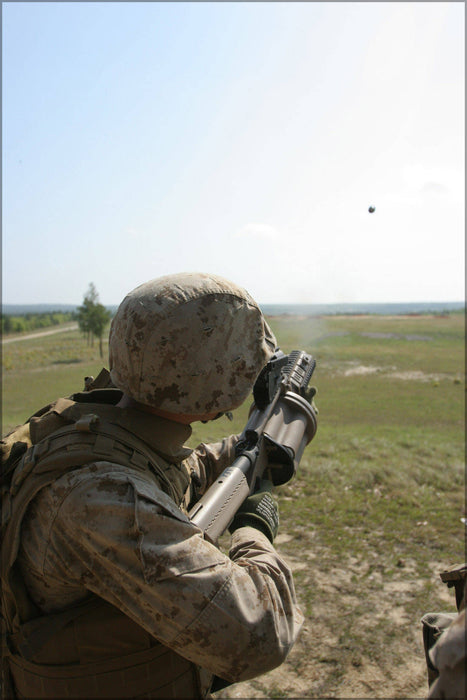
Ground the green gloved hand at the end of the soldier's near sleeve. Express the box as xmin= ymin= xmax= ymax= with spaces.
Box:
xmin=229 ymin=479 xmax=279 ymax=542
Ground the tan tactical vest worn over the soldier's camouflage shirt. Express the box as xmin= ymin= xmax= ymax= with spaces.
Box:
xmin=2 ymin=389 xmax=212 ymax=698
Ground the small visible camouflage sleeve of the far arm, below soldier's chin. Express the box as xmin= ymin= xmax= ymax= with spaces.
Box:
xmin=185 ymin=435 xmax=240 ymax=497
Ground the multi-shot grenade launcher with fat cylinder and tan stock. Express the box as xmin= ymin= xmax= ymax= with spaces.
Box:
xmin=188 ymin=349 xmax=317 ymax=543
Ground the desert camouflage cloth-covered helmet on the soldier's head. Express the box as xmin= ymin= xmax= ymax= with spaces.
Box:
xmin=109 ymin=273 xmax=276 ymax=415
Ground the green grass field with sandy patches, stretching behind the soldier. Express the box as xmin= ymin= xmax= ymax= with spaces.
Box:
xmin=2 ymin=313 xmax=465 ymax=698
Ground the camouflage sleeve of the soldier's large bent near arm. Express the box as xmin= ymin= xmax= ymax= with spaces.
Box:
xmin=32 ymin=470 xmax=303 ymax=681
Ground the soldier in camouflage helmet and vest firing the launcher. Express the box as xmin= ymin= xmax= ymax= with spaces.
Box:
xmin=2 ymin=274 xmax=303 ymax=698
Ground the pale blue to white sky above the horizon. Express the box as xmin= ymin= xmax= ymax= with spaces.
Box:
xmin=2 ymin=2 xmax=465 ymax=305
